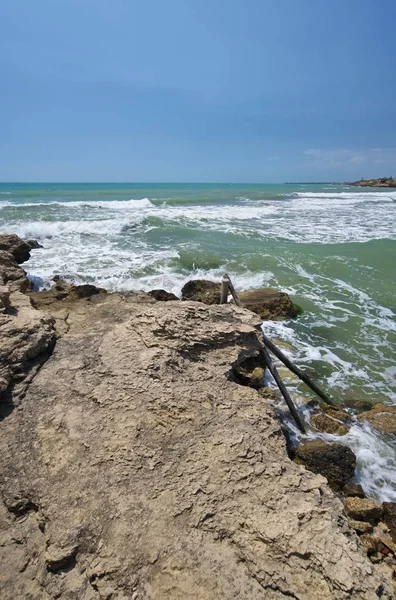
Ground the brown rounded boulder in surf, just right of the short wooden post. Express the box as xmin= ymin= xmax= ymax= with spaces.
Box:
xmin=235 ymin=288 xmax=298 ymax=320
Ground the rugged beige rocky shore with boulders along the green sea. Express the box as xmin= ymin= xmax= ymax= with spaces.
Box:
xmin=0 ymin=236 xmax=396 ymax=600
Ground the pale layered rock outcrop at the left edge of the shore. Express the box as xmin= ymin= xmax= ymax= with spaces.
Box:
xmin=0 ymin=292 xmax=55 ymax=417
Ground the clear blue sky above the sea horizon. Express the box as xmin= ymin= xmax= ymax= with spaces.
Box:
xmin=0 ymin=0 xmax=396 ymax=182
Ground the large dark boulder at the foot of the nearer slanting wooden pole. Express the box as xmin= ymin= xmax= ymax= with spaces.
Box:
xmin=296 ymin=441 xmax=357 ymax=490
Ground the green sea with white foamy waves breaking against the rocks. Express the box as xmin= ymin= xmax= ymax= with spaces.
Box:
xmin=0 ymin=183 xmax=396 ymax=501
